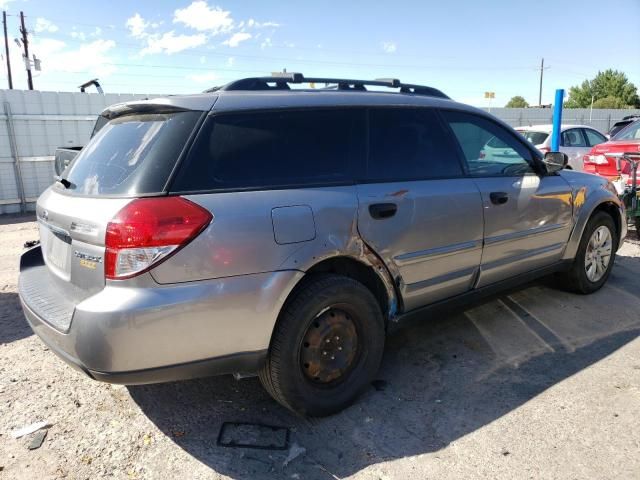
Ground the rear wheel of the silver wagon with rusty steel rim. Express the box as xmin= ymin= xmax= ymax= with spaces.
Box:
xmin=259 ymin=274 xmax=385 ymax=416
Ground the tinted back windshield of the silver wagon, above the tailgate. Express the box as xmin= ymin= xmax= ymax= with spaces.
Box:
xmin=58 ymin=111 xmax=202 ymax=197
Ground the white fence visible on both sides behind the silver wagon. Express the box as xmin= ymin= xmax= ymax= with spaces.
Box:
xmin=0 ymin=90 xmax=640 ymax=213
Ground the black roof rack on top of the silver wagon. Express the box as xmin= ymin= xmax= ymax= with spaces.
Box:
xmin=210 ymin=72 xmax=449 ymax=99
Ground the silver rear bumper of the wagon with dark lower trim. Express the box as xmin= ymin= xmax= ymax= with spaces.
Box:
xmin=19 ymin=247 xmax=303 ymax=384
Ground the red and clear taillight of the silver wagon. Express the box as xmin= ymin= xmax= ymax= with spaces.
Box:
xmin=105 ymin=197 xmax=213 ymax=280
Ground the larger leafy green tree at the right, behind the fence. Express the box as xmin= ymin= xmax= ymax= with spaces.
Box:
xmin=564 ymin=69 xmax=640 ymax=108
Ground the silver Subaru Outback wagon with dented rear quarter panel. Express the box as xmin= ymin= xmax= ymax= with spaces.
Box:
xmin=19 ymin=74 xmax=627 ymax=415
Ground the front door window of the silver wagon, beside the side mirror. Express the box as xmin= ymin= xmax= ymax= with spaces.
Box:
xmin=442 ymin=111 xmax=533 ymax=177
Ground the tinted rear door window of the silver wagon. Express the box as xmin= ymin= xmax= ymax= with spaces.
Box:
xmin=367 ymin=108 xmax=462 ymax=181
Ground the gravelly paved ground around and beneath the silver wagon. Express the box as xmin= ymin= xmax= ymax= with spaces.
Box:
xmin=0 ymin=217 xmax=640 ymax=480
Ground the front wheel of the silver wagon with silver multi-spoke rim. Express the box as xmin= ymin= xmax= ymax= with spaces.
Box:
xmin=562 ymin=212 xmax=619 ymax=294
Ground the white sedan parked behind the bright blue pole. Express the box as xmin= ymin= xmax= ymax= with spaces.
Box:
xmin=516 ymin=125 xmax=607 ymax=172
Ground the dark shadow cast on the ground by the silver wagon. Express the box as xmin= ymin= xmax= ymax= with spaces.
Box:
xmin=129 ymin=256 xmax=640 ymax=480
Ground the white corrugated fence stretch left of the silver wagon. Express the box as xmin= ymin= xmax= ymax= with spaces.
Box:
xmin=0 ymin=90 xmax=151 ymax=213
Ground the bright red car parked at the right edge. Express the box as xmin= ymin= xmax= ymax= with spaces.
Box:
xmin=583 ymin=120 xmax=640 ymax=186
